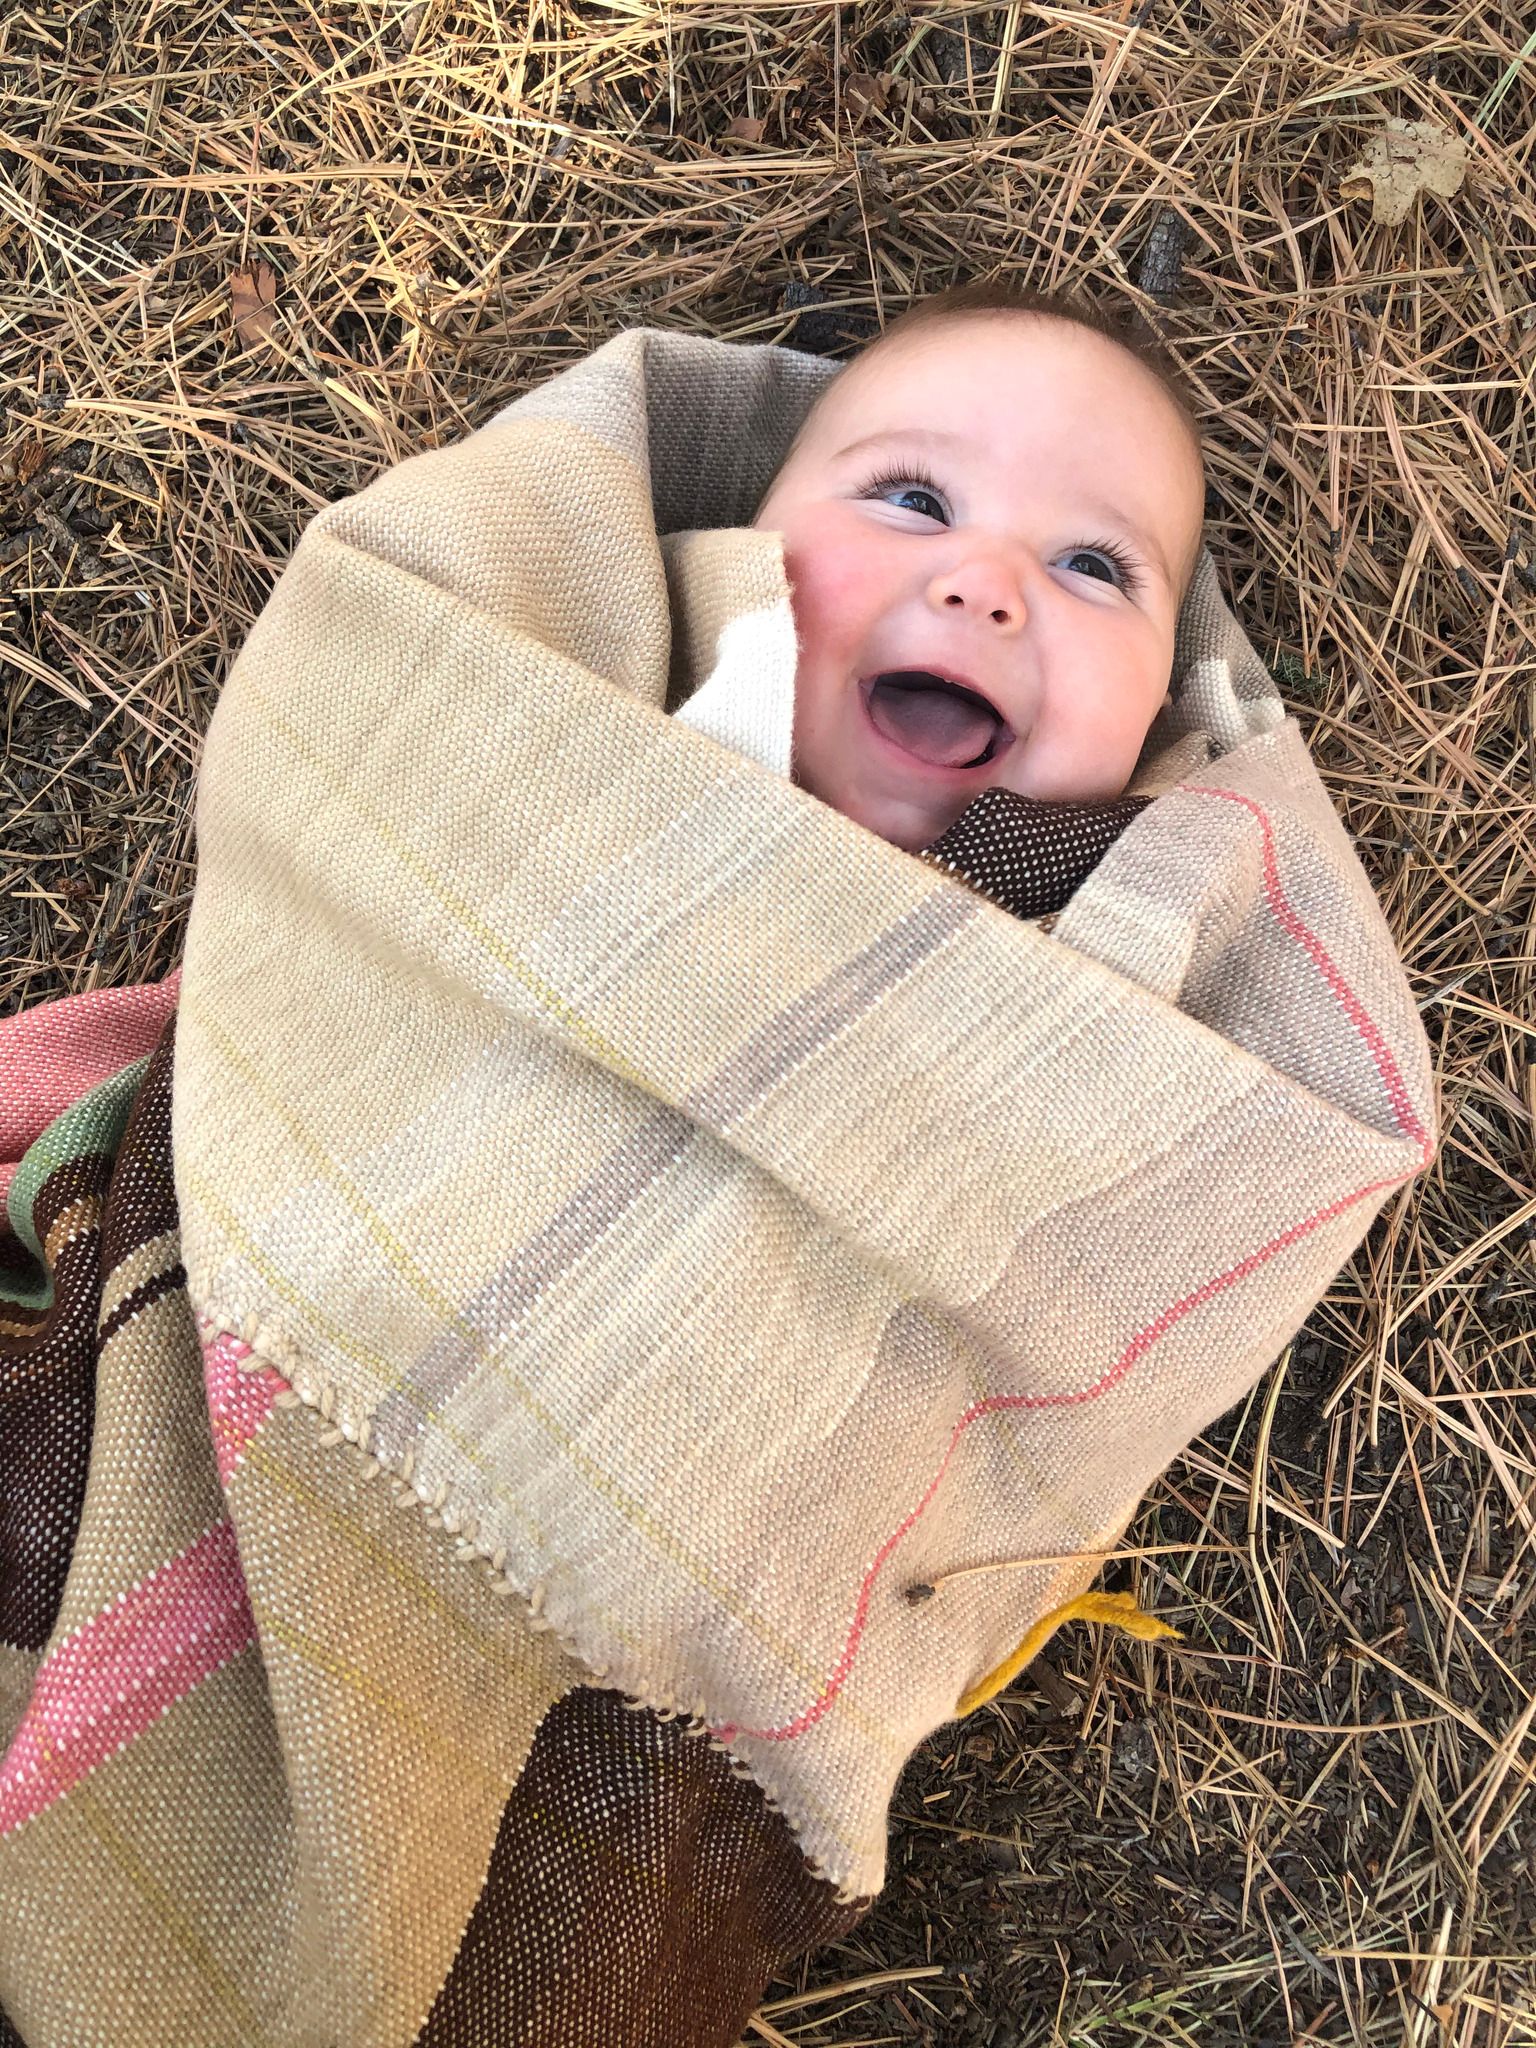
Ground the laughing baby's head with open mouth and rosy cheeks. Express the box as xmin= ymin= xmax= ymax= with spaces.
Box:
xmin=754 ymin=313 xmax=1204 ymax=852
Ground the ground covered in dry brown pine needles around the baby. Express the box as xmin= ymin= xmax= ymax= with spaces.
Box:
xmin=0 ymin=0 xmax=1536 ymax=2048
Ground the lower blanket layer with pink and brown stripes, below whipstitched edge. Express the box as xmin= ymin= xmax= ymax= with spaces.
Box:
xmin=0 ymin=1024 xmax=854 ymax=2048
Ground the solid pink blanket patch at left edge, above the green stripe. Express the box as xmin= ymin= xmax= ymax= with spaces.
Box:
xmin=0 ymin=967 xmax=182 ymax=1202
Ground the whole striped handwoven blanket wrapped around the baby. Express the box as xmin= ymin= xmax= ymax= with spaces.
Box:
xmin=0 ymin=330 xmax=1434 ymax=2048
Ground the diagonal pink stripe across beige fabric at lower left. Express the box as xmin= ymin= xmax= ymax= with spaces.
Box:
xmin=0 ymin=1522 xmax=256 ymax=1835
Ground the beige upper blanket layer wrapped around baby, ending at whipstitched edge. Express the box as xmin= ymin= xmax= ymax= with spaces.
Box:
xmin=172 ymin=330 xmax=1434 ymax=1894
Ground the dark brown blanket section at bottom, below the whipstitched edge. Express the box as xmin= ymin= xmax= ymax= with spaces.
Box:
xmin=416 ymin=1688 xmax=868 ymax=2048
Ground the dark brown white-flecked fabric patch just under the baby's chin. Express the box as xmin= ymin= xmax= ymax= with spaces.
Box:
xmin=920 ymin=788 xmax=1153 ymax=918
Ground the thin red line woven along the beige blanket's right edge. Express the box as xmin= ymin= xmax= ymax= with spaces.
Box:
xmin=711 ymin=782 xmax=1434 ymax=1743
